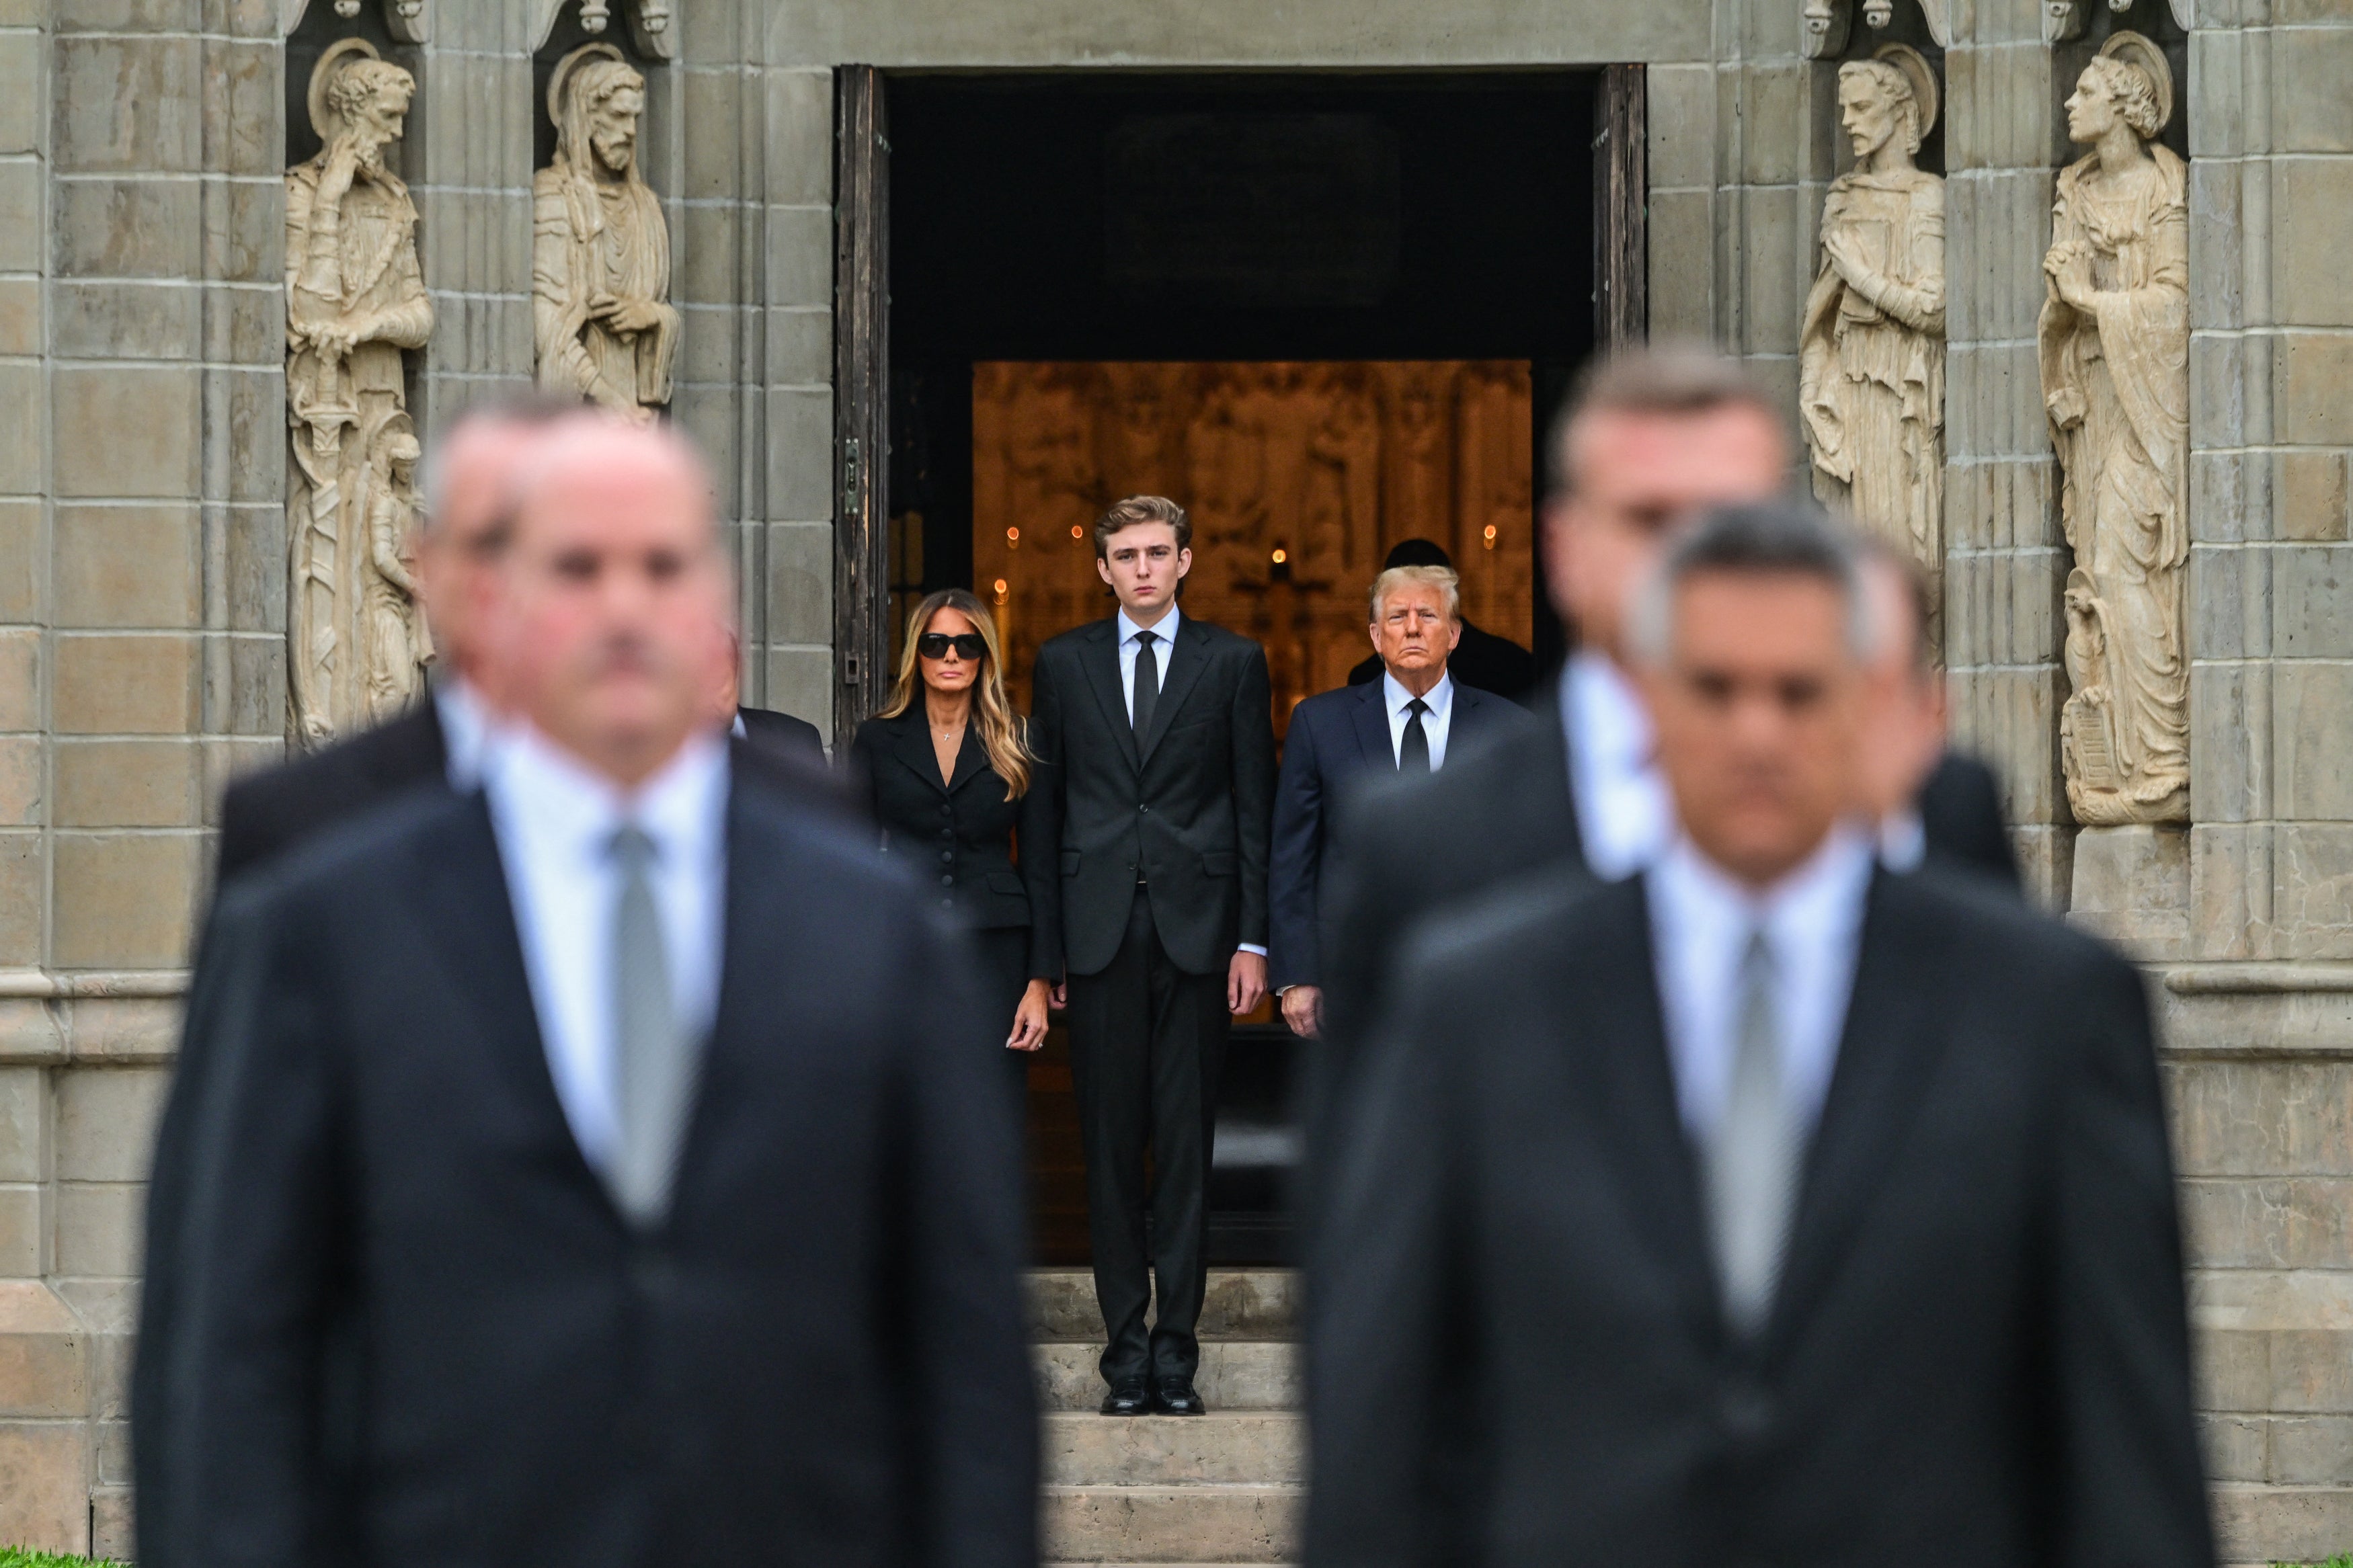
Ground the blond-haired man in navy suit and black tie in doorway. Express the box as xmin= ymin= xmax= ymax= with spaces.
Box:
xmin=1269 ymin=567 xmax=1534 ymax=1039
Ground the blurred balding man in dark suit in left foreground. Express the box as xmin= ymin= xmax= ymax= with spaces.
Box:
xmin=141 ymin=428 xmax=1038 ymax=1568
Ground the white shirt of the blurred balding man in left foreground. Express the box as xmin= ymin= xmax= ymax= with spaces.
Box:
xmin=483 ymin=724 xmax=727 ymax=1171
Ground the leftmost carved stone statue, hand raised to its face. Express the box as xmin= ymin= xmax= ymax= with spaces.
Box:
xmin=287 ymin=38 xmax=433 ymax=745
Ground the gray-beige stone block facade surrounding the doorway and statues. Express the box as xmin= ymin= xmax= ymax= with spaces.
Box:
xmin=0 ymin=0 xmax=2353 ymax=1563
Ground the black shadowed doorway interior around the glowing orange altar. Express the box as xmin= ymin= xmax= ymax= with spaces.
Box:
xmin=889 ymin=71 xmax=1598 ymax=1262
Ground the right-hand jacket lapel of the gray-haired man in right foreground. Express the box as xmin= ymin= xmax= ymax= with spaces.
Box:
xmin=1767 ymin=870 xmax=1948 ymax=1342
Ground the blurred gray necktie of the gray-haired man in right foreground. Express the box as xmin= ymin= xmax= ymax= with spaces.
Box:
xmin=1706 ymin=931 xmax=1805 ymax=1337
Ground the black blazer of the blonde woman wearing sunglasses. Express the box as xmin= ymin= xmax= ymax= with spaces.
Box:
xmin=850 ymin=703 xmax=1062 ymax=981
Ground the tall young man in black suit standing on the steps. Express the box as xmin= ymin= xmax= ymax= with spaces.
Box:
xmin=1021 ymin=496 xmax=1275 ymax=1415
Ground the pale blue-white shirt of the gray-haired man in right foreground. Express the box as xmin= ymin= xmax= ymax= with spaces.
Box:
xmin=1645 ymin=825 xmax=1873 ymax=1140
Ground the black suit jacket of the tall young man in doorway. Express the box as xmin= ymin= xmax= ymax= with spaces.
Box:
xmin=1024 ymin=616 xmax=1275 ymax=976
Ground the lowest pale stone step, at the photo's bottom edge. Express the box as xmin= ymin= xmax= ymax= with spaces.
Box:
xmin=1038 ymin=1486 xmax=1306 ymax=1563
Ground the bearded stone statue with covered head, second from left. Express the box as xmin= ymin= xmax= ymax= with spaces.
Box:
xmin=532 ymin=42 xmax=680 ymax=419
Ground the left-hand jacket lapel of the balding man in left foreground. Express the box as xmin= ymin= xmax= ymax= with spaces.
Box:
xmin=414 ymin=792 xmax=605 ymax=1196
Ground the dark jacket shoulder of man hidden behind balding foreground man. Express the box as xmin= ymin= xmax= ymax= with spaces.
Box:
xmin=214 ymin=700 xmax=450 ymax=886
